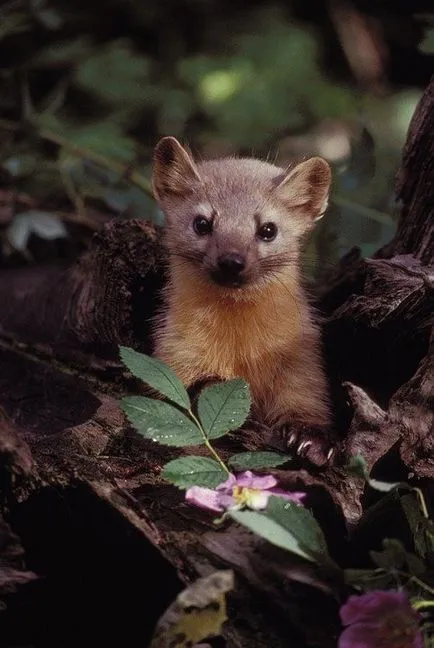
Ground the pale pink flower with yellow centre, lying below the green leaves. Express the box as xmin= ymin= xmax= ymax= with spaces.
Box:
xmin=185 ymin=470 xmax=306 ymax=513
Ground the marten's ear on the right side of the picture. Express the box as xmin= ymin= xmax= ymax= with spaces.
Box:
xmin=276 ymin=157 xmax=332 ymax=221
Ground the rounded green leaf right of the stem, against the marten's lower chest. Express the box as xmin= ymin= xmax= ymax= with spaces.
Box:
xmin=197 ymin=378 xmax=251 ymax=439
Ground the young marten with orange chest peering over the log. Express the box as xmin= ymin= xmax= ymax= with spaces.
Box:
xmin=152 ymin=137 xmax=331 ymax=456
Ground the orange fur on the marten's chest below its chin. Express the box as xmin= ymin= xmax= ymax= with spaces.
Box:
xmin=157 ymin=274 xmax=302 ymax=391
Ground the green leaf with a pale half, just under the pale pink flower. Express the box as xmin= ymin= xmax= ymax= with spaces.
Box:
xmin=229 ymin=497 xmax=332 ymax=565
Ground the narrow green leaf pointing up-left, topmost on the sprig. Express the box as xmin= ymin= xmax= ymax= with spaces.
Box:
xmin=119 ymin=346 xmax=191 ymax=410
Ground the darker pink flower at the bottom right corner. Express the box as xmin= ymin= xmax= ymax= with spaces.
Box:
xmin=338 ymin=590 xmax=423 ymax=648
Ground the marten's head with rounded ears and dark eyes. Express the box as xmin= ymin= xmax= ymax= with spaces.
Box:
xmin=152 ymin=137 xmax=331 ymax=290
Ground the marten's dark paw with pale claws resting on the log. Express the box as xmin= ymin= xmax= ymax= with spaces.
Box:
xmin=281 ymin=422 xmax=336 ymax=466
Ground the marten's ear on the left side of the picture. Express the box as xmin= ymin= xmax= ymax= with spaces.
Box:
xmin=152 ymin=137 xmax=200 ymax=200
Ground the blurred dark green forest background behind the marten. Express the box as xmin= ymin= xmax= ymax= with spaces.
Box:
xmin=0 ymin=0 xmax=434 ymax=277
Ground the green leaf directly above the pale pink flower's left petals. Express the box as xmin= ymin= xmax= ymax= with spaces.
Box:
xmin=162 ymin=457 xmax=228 ymax=488
